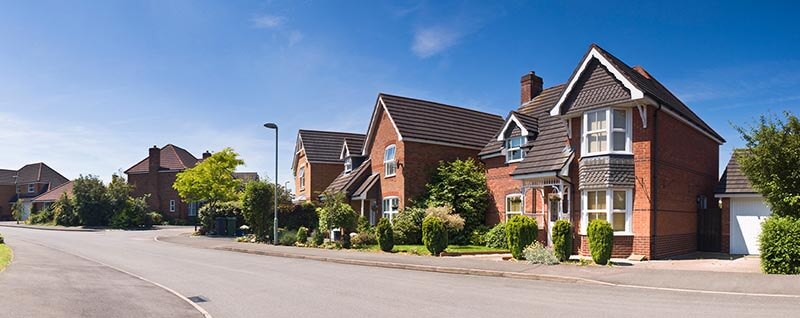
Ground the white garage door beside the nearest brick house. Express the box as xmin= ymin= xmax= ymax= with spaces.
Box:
xmin=731 ymin=198 xmax=771 ymax=254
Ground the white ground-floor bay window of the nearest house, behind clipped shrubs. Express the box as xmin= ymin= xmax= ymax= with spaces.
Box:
xmin=581 ymin=189 xmax=633 ymax=234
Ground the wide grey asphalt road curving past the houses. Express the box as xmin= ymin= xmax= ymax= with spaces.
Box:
xmin=0 ymin=228 xmax=800 ymax=318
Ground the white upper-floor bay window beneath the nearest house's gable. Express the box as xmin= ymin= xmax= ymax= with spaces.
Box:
xmin=581 ymin=108 xmax=631 ymax=155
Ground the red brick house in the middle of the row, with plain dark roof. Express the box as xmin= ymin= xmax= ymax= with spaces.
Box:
xmin=338 ymin=94 xmax=503 ymax=223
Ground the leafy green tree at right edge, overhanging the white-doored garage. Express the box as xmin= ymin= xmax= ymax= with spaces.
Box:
xmin=734 ymin=111 xmax=800 ymax=219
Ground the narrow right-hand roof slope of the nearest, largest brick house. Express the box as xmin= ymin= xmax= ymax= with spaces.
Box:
xmin=590 ymin=44 xmax=725 ymax=142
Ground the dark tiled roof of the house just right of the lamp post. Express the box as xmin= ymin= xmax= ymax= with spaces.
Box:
xmin=298 ymin=129 xmax=364 ymax=162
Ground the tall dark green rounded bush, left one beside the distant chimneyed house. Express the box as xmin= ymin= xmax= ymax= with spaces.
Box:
xmin=72 ymin=175 xmax=112 ymax=226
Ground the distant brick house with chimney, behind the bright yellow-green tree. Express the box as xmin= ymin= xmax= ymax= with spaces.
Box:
xmin=125 ymin=144 xmax=258 ymax=221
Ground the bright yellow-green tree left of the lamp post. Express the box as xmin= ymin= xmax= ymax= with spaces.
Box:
xmin=172 ymin=148 xmax=244 ymax=210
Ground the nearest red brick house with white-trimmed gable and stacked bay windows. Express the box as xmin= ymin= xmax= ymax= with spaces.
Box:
xmin=481 ymin=45 xmax=725 ymax=259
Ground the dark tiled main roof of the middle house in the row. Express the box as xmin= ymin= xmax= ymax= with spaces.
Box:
xmin=378 ymin=93 xmax=504 ymax=148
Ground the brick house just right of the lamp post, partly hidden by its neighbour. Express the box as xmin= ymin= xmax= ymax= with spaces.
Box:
xmin=292 ymin=129 xmax=364 ymax=202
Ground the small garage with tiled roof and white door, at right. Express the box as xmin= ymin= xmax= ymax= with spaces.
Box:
xmin=714 ymin=149 xmax=772 ymax=255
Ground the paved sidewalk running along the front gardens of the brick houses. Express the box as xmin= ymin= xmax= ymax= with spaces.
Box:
xmin=158 ymin=234 xmax=800 ymax=298
